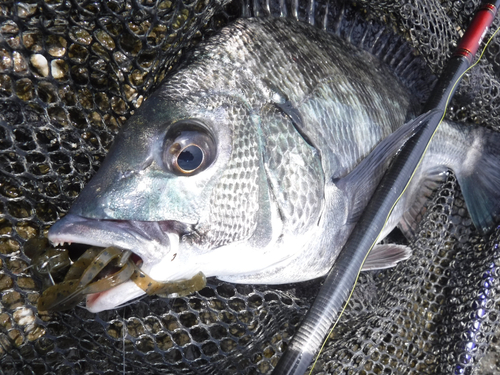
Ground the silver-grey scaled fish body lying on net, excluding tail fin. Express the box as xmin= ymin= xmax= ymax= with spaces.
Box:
xmin=49 ymin=19 xmax=497 ymax=311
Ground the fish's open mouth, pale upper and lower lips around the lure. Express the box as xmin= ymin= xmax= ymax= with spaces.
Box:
xmin=48 ymin=214 xmax=188 ymax=312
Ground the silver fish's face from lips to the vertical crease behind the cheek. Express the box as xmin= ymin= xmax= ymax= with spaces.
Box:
xmin=49 ymin=84 xmax=288 ymax=312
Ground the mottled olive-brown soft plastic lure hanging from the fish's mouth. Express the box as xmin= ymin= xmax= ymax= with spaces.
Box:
xmin=29 ymin=239 xmax=206 ymax=312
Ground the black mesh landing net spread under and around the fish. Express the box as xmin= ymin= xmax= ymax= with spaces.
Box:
xmin=0 ymin=0 xmax=500 ymax=374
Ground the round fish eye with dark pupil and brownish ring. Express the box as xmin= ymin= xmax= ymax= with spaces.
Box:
xmin=163 ymin=121 xmax=216 ymax=176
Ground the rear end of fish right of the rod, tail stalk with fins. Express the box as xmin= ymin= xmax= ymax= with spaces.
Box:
xmin=395 ymin=122 xmax=500 ymax=239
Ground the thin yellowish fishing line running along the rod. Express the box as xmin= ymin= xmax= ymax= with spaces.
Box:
xmin=309 ymin=22 xmax=500 ymax=375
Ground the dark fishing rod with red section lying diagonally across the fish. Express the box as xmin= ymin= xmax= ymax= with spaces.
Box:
xmin=273 ymin=0 xmax=500 ymax=375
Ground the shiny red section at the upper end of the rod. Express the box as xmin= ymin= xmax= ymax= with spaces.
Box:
xmin=455 ymin=2 xmax=498 ymax=62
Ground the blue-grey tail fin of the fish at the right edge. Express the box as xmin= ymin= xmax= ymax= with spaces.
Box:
xmin=452 ymin=128 xmax=500 ymax=233
